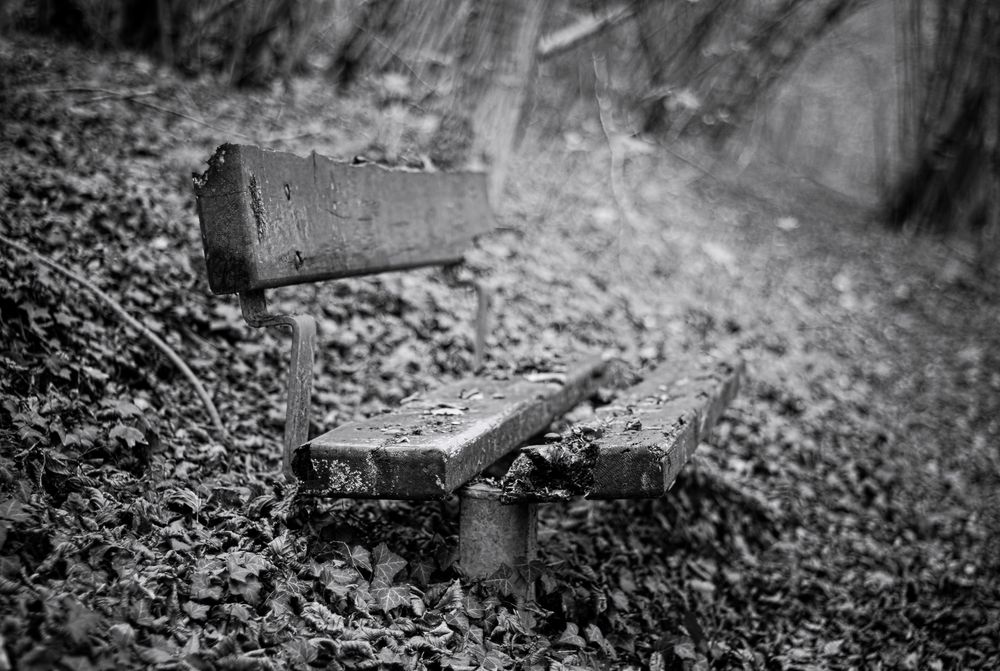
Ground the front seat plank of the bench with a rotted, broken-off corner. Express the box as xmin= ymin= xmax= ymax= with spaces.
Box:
xmin=501 ymin=355 xmax=743 ymax=501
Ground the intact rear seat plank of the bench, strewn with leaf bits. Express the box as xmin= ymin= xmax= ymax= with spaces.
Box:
xmin=292 ymin=359 xmax=607 ymax=499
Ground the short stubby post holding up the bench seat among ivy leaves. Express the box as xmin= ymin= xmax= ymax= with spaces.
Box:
xmin=458 ymin=483 xmax=538 ymax=600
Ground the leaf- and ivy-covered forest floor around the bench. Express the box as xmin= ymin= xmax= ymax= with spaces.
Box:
xmin=0 ymin=37 xmax=1000 ymax=669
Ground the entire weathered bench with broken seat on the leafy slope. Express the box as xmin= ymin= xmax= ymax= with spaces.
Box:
xmin=195 ymin=145 xmax=740 ymax=588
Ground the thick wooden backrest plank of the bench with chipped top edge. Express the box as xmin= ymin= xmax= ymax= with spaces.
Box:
xmin=195 ymin=145 xmax=495 ymax=294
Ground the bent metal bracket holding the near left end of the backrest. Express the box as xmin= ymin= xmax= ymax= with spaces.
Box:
xmin=239 ymin=290 xmax=316 ymax=478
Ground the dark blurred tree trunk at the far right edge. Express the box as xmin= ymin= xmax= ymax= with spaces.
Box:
xmin=887 ymin=0 xmax=1000 ymax=266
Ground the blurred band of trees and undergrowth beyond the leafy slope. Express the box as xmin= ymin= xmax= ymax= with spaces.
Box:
xmin=0 ymin=0 xmax=1000 ymax=266
